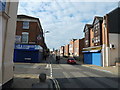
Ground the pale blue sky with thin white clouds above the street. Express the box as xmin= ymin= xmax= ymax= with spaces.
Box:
xmin=18 ymin=0 xmax=118 ymax=49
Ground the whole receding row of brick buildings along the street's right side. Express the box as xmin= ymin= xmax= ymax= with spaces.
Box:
xmin=55 ymin=7 xmax=120 ymax=67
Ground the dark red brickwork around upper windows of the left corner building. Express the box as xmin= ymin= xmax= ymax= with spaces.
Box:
xmin=16 ymin=21 xmax=45 ymax=47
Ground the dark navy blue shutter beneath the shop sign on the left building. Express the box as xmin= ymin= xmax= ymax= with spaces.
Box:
xmin=13 ymin=49 xmax=43 ymax=63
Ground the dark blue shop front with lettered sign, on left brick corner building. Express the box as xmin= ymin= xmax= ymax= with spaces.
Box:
xmin=13 ymin=44 xmax=43 ymax=63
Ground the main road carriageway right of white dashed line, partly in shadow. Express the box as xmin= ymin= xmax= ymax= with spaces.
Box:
xmin=48 ymin=57 xmax=120 ymax=89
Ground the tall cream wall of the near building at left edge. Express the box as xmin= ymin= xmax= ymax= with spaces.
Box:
xmin=0 ymin=2 xmax=18 ymax=84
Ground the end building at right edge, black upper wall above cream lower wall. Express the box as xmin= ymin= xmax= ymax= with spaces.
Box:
xmin=103 ymin=7 xmax=120 ymax=66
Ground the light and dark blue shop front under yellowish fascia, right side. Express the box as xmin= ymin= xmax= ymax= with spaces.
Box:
xmin=82 ymin=47 xmax=102 ymax=66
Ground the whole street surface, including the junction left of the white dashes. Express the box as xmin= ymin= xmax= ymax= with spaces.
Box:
xmin=13 ymin=57 xmax=118 ymax=89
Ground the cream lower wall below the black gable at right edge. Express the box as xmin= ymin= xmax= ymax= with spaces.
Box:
xmin=109 ymin=33 xmax=120 ymax=65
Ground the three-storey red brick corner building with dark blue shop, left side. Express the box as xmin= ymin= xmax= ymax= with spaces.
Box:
xmin=14 ymin=15 xmax=47 ymax=62
